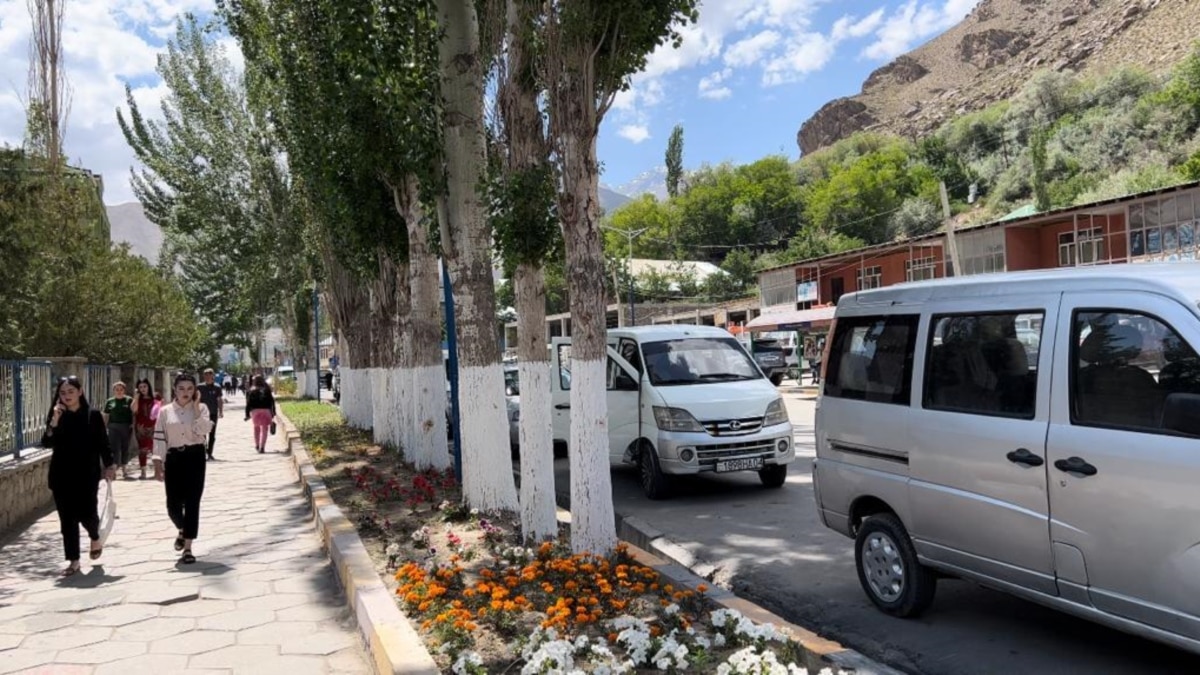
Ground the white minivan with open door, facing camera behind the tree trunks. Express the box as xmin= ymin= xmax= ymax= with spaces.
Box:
xmin=551 ymin=325 xmax=796 ymax=500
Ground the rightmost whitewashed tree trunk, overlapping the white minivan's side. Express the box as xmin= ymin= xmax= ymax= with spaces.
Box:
xmin=550 ymin=40 xmax=617 ymax=554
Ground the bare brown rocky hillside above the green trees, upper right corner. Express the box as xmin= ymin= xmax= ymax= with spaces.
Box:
xmin=797 ymin=0 xmax=1200 ymax=154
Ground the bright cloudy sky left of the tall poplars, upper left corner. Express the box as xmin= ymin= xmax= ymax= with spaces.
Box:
xmin=0 ymin=0 xmax=220 ymax=204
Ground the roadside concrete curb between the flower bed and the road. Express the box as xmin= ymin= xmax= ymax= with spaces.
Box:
xmin=544 ymin=477 xmax=904 ymax=675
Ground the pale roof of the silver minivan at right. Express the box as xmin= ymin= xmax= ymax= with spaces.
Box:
xmin=838 ymin=262 xmax=1200 ymax=311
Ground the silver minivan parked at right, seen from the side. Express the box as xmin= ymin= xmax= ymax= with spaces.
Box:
xmin=814 ymin=263 xmax=1200 ymax=653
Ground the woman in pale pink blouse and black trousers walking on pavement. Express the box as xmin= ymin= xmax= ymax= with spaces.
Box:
xmin=154 ymin=372 xmax=212 ymax=565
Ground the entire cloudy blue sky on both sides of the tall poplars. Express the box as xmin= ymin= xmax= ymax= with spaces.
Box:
xmin=0 ymin=0 xmax=979 ymax=204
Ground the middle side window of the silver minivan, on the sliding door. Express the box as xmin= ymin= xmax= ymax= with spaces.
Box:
xmin=923 ymin=312 xmax=1044 ymax=419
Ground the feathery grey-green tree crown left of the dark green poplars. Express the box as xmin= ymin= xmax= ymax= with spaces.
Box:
xmin=118 ymin=16 xmax=306 ymax=346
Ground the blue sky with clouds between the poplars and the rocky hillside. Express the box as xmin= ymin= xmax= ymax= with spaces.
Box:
xmin=600 ymin=0 xmax=978 ymax=185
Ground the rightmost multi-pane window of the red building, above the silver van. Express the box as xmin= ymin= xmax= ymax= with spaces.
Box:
xmin=1129 ymin=192 xmax=1200 ymax=262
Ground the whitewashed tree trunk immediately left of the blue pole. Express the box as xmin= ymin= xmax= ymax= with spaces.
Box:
xmin=392 ymin=177 xmax=450 ymax=468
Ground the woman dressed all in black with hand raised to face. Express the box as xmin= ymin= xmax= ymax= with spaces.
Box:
xmin=42 ymin=376 xmax=116 ymax=577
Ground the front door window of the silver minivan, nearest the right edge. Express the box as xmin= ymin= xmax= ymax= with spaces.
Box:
xmin=1070 ymin=309 xmax=1200 ymax=431
